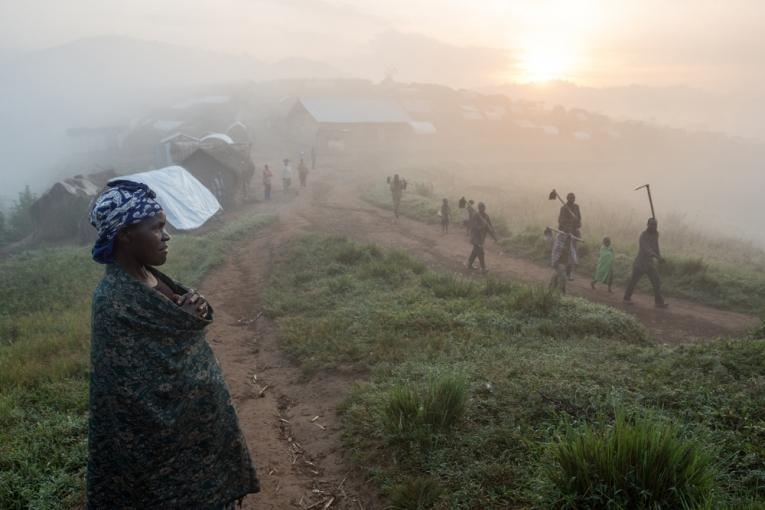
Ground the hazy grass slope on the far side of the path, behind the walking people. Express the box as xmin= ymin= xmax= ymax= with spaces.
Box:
xmin=363 ymin=183 xmax=765 ymax=316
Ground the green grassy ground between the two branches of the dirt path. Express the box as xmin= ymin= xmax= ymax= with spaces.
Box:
xmin=265 ymin=237 xmax=765 ymax=510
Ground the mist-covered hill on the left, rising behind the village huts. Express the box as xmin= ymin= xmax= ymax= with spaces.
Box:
xmin=0 ymin=37 xmax=341 ymax=195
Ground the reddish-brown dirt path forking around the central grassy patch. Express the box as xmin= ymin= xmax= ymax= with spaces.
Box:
xmin=200 ymin=169 xmax=756 ymax=510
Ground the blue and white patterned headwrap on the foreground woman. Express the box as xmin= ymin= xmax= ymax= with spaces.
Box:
xmin=90 ymin=180 xmax=162 ymax=264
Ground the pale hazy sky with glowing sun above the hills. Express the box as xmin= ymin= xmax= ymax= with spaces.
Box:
xmin=0 ymin=0 xmax=765 ymax=92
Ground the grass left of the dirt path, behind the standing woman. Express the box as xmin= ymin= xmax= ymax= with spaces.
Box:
xmin=0 ymin=215 xmax=275 ymax=510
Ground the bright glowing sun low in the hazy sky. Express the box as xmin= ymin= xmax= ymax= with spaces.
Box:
xmin=520 ymin=37 xmax=577 ymax=82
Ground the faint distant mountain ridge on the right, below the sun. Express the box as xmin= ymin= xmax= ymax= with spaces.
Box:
xmin=482 ymin=81 xmax=765 ymax=139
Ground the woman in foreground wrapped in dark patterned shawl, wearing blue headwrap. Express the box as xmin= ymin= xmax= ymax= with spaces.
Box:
xmin=87 ymin=181 xmax=259 ymax=510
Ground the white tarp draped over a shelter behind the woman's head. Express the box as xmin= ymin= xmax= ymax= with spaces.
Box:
xmin=112 ymin=166 xmax=221 ymax=230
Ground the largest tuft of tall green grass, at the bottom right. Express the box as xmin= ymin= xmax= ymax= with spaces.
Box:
xmin=550 ymin=415 xmax=713 ymax=509
